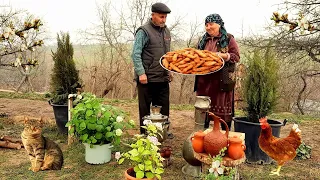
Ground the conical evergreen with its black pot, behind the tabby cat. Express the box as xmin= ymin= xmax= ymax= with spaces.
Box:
xmin=49 ymin=33 xmax=81 ymax=133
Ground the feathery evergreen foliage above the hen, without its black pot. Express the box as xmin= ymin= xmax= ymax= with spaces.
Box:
xmin=244 ymin=45 xmax=279 ymax=123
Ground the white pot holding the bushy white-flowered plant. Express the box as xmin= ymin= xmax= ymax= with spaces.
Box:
xmin=83 ymin=143 xmax=113 ymax=164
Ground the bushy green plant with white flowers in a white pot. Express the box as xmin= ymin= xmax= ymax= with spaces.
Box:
xmin=66 ymin=93 xmax=134 ymax=164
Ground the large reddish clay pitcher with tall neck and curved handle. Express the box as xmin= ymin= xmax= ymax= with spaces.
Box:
xmin=204 ymin=112 xmax=229 ymax=156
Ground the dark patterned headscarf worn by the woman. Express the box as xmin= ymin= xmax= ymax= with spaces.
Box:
xmin=198 ymin=14 xmax=229 ymax=49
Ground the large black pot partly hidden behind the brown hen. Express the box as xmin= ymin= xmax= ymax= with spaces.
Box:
xmin=233 ymin=117 xmax=285 ymax=164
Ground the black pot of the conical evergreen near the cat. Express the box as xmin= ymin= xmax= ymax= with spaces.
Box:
xmin=49 ymin=101 xmax=68 ymax=134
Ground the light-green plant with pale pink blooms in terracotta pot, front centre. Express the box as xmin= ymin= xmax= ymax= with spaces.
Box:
xmin=116 ymin=123 xmax=164 ymax=180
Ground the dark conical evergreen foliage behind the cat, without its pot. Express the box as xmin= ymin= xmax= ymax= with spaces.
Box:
xmin=50 ymin=33 xmax=81 ymax=105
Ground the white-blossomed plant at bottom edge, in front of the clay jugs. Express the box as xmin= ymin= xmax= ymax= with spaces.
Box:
xmin=204 ymin=147 xmax=235 ymax=180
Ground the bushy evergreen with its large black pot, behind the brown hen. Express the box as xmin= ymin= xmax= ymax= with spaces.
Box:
xmin=233 ymin=46 xmax=283 ymax=164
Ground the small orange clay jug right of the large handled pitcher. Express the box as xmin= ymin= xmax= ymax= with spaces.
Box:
xmin=228 ymin=136 xmax=246 ymax=160
